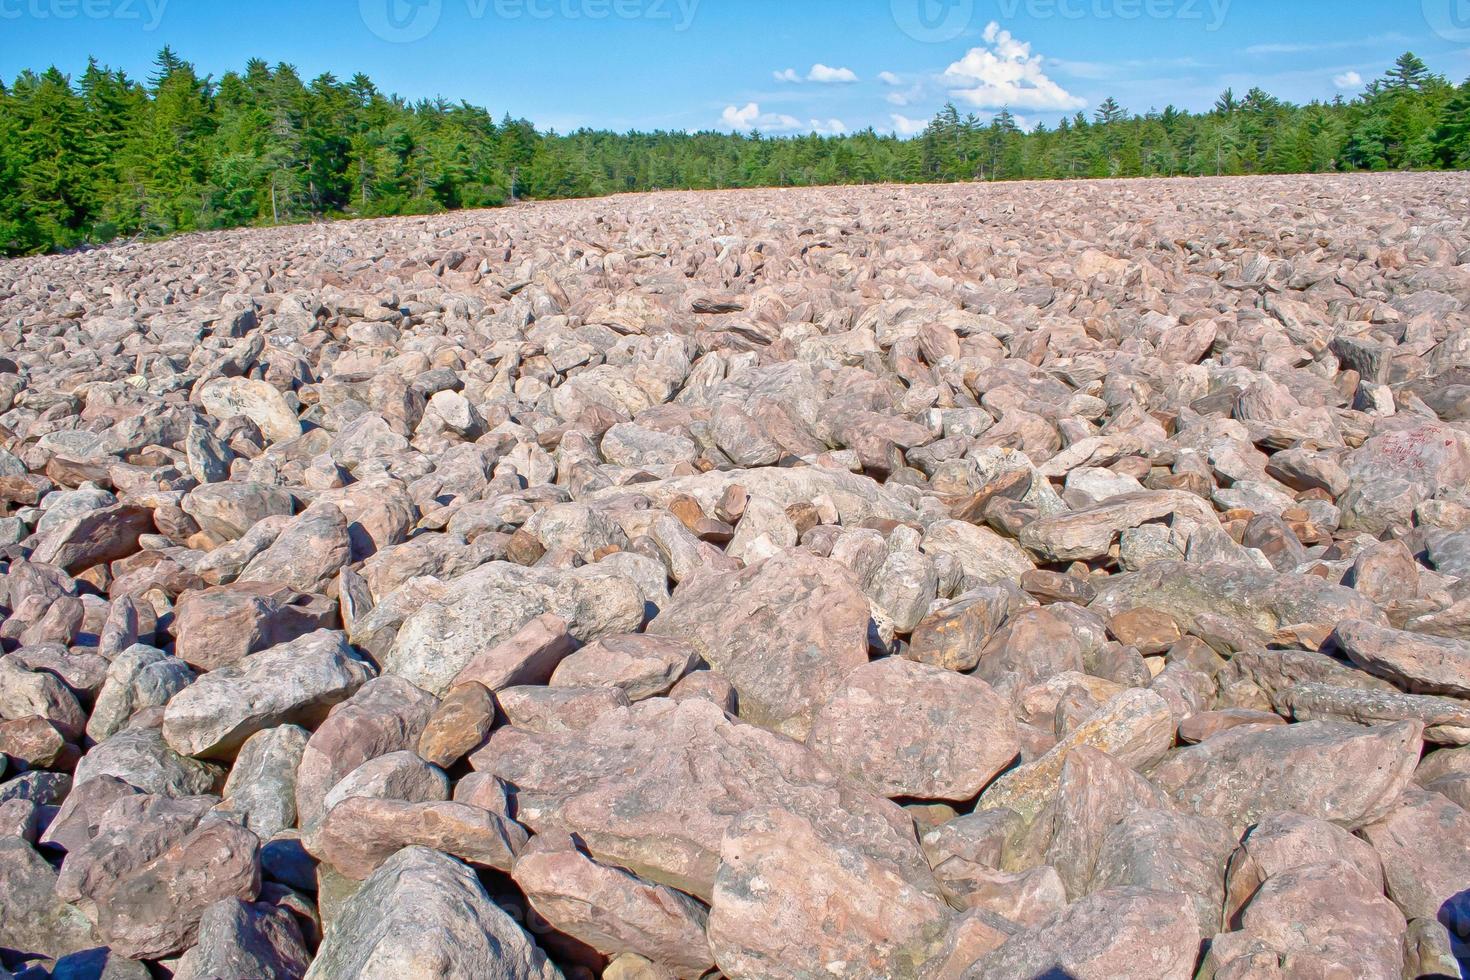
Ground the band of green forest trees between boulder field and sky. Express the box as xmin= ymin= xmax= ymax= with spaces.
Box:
xmin=0 ymin=48 xmax=1470 ymax=256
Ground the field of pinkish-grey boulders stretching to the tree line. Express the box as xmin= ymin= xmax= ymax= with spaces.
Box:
xmin=0 ymin=175 xmax=1470 ymax=980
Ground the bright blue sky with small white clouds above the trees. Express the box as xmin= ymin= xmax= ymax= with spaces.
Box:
xmin=0 ymin=0 xmax=1470 ymax=134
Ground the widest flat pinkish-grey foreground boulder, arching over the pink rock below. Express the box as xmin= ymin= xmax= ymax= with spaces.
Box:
xmin=470 ymin=699 xmax=936 ymax=899
